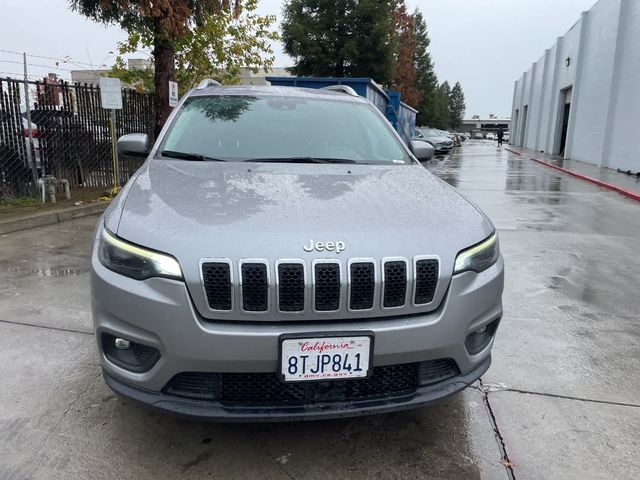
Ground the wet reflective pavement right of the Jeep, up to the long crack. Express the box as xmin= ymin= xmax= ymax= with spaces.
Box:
xmin=427 ymin=141 xmax=640 ymax=479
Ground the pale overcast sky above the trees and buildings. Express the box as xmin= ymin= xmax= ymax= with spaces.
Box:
xmin=0 ymin=0 xmax=595 ymax=117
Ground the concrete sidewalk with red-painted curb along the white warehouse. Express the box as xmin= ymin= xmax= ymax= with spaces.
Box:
xmin=504 ymin=145 xmax=640 ymax=200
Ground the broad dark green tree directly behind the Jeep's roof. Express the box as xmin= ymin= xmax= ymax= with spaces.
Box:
xmin=282 ymin=0 xmax=394 ymax=85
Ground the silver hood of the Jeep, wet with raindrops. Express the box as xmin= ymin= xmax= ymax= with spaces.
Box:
xmin=106 ymin=160 xmax=493 ymax=318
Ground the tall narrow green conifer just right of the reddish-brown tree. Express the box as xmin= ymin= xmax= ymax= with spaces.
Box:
xmin=413 ymin=8 xmax=438 ymax=125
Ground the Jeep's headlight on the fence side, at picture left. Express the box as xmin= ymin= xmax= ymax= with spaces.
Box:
xmin=98 ymin=227 xmax=182 ymax=280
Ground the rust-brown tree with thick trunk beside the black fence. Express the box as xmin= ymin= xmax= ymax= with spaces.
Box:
xmin=69 ymin=0 xmax=270 ymax=133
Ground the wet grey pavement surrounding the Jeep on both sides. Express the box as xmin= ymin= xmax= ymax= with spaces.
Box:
xmin=0 ymin=141 xmax=640 ymax=480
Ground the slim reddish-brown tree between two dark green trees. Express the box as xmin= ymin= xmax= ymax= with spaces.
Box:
xmin=392 ymin=0 xmax=422 ymax=107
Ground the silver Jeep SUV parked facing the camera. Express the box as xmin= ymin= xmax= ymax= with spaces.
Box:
xmin=92 ymin=84 xmax=503 ymax=421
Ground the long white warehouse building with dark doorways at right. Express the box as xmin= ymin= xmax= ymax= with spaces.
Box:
xmin=511 ymin=0 xmax=640 ymax=172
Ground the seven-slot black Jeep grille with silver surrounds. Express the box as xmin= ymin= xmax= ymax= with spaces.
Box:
xmin=201 ymin=257 xmax=440 ymax=314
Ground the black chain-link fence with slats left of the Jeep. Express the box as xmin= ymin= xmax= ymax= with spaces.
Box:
xmin=0 ymin=78 xmax=154 ymax=200
